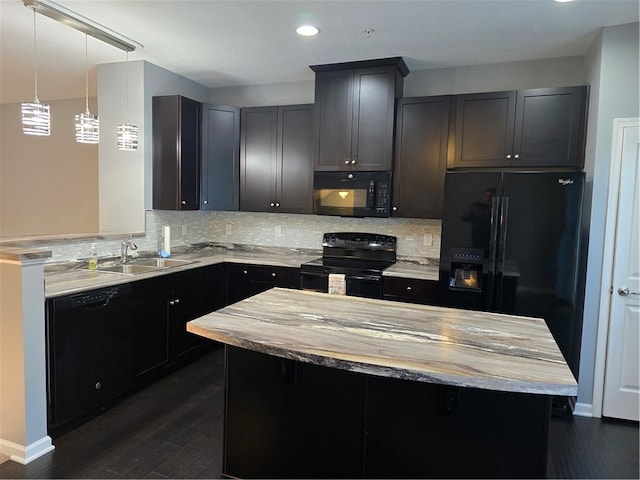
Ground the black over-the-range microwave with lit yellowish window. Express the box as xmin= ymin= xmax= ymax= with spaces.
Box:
xmin=313 ymin=172 xmax=391 ymax=217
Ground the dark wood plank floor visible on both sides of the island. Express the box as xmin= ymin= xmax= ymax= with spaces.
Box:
xmin=0 ymin=348 xmax=639 ymax=479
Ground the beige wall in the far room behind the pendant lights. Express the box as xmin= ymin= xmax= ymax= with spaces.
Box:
xmin=0 ymin=98 xmax=98 ymax=238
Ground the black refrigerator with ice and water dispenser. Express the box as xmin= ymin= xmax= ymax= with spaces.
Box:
xmin=438 ymin=171 xmax=584 ymax=378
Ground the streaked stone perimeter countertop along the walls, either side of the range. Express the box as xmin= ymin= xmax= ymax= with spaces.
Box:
xmin=41 ymin=244 xmax=438 ymax=298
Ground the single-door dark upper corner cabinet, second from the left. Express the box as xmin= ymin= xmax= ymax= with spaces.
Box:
xmin=200 ymin=105 xmax=240 ymax=210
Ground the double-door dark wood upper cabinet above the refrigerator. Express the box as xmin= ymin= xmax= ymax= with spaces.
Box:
xmin=449 ymin=86 xmax=588 ymax=168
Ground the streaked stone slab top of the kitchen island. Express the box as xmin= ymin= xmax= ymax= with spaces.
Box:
xmin=187 ymin=288 xmax=577 ymax=396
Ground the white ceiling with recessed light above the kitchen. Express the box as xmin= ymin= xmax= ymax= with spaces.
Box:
xmin=0 ymin=0 xmax=640 ymax=103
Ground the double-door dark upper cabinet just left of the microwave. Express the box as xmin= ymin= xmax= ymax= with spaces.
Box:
xmin=240 ymin=105 xmax=313 ymax=213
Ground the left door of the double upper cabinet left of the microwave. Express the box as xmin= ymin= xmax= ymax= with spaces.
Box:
xmin=240 ymin=107 xmax=278 ymax=212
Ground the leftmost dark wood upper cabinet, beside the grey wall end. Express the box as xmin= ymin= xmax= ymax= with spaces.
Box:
xmin=152 ymin=95 xmax=201 ymax=210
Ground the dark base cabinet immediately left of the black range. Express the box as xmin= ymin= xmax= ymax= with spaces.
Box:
xmin=227 ymin=263 xmax=300 ymax=305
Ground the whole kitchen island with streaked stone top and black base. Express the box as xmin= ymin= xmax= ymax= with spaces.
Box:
xmin=187 ymin=288 xmax=577 ymax=478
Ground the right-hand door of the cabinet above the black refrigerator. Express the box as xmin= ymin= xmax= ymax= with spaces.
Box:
xmin=513 ymin=87 xmax=587 ymax=168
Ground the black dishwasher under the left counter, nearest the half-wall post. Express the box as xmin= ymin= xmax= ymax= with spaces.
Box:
xmin=47 ymin=284 xmax=133 ymax=433
